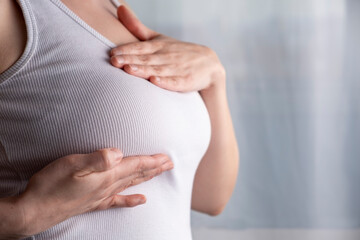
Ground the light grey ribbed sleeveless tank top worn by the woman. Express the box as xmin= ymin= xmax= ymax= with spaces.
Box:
xmin=0 ymin=0 xmax=211 ymax=240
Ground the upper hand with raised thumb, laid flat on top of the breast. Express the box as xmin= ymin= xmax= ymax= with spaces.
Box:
xmin=111 ymin=5 xmax=225 ymax=92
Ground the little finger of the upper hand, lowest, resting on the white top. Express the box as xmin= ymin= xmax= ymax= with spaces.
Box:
xmin=149 ymin=76 xmax=190 ymax=92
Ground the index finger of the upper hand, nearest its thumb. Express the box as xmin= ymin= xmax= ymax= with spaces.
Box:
xmin=110 ymin=40 xmax=165 ymax=56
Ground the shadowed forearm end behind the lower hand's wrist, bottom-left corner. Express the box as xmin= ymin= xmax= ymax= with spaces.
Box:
xmin=0 ymin=197 xmax=26 ymax=239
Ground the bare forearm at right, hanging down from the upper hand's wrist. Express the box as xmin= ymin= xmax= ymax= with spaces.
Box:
xmin=192 ymin=77 xmax=239 ymax=215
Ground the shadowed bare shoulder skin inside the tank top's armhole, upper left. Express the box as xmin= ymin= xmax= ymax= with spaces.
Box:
xmin=0 ymin=0 xmax=27 ymax=74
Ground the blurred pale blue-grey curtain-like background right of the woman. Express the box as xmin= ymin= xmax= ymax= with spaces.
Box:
xmin=127 ymin=0 xmax=360 ymax=240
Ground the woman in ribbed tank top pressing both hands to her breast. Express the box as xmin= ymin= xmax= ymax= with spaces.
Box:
xmin=0 ymin=0 xmax=238 ymax=240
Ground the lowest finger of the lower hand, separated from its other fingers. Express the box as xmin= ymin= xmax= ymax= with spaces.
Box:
xmin=94 ymin=194 xmax=146 ymax=210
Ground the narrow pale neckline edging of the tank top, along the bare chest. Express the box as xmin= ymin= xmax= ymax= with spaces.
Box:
xmin=50 ymin=0 xmax=116 ymax=48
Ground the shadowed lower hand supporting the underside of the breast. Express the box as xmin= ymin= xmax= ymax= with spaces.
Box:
xmin=13 ymin=148 xmax=173 ymax=236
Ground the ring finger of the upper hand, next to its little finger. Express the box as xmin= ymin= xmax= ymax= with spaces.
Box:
xmin=124 ymin=64 xmax=182 ymax=79
